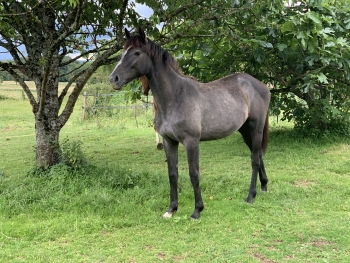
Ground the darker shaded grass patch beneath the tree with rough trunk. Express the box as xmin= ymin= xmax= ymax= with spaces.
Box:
xmin=0 ymin=164 xmax=168 ymax=220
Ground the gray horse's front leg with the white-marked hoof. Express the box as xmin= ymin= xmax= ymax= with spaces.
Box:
xmin=163 ymin=138 xmax=179 ymax=218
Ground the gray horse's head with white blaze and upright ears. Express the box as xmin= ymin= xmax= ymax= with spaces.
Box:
xmin=109 ymin=28 xmax=152 ymax=89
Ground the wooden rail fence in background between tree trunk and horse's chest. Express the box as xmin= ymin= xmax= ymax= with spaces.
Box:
xmin=82 ymin=91 xmax=153 ymax=119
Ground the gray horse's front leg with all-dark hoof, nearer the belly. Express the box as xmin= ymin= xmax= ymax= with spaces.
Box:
xmin=184 ymin=139 xmax=204 ymax=219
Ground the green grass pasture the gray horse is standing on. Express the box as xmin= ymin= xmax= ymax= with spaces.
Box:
xmin=0 ymin=82 xmax=350 ymax=263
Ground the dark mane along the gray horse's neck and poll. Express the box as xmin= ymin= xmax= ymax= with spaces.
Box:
xmin=124 ymin=35 xmax=183 ymax=75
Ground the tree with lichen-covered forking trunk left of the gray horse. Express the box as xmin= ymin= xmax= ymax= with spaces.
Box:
xmin=0 ymin=0 xmax=213 ymax=167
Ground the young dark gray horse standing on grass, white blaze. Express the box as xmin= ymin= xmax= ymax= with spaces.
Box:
xmin=110 ymin=29 xmax=270 ymax=219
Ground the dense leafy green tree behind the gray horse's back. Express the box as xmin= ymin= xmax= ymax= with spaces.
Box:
xmin=161 ymin=0 xmax=350 ymax=134
